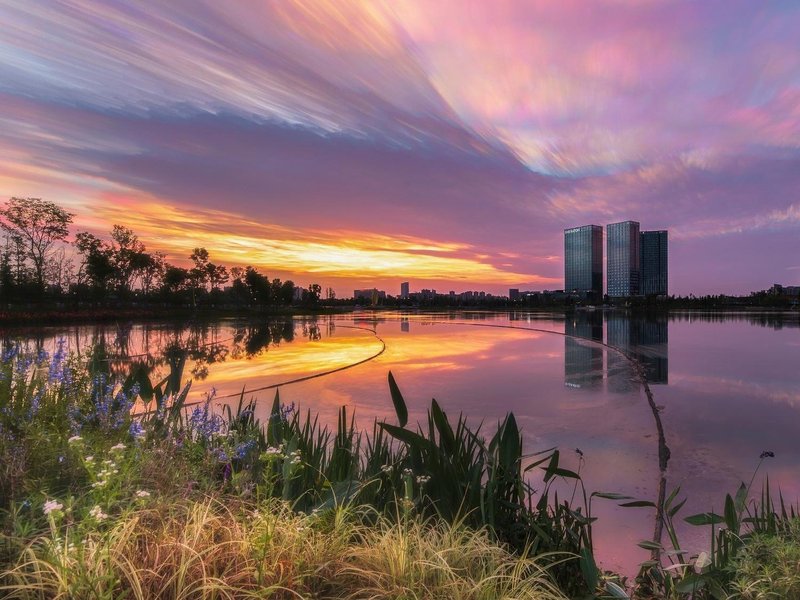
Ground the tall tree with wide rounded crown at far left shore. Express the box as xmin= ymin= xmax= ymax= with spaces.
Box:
xmin=0 ymin=198 xmax=75 ymax=291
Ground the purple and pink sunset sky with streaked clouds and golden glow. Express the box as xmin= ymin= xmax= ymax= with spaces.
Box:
xmin=0 ymin=0 xmax=800 ymax=296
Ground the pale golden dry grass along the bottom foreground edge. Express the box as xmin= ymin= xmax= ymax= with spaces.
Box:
xmin=0 ymin=499 xmax=563 ymax=600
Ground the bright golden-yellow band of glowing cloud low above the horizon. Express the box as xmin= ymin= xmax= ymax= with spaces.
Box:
xmin=95 ymin=197 xmax=557 ymax=285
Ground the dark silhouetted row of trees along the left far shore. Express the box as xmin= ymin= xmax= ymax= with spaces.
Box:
xmin=0 ymin=198 xmax=333 ymax=307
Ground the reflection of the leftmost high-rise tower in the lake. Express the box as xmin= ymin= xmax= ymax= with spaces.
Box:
xmin=564 ymin=311 xmax=603 ymax=388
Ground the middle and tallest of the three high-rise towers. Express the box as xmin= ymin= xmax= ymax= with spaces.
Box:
xmin=606 ymin=221 xmax=641 ymax=298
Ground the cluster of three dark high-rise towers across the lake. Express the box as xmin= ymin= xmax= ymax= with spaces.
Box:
xmin=564 ymin=221 xmax=668 ymax=301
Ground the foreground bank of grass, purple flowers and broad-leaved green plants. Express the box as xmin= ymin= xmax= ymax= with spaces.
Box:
xmin=0 ymin=340 xmax=797 ymax=598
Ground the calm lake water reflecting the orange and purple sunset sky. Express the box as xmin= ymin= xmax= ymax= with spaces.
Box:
xmin=2 ymin=311 xmax=800 ymax=573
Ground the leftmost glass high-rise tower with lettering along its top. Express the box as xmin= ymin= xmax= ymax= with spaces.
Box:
xmin=564 ymin=225 xmax=603 ymax=300
